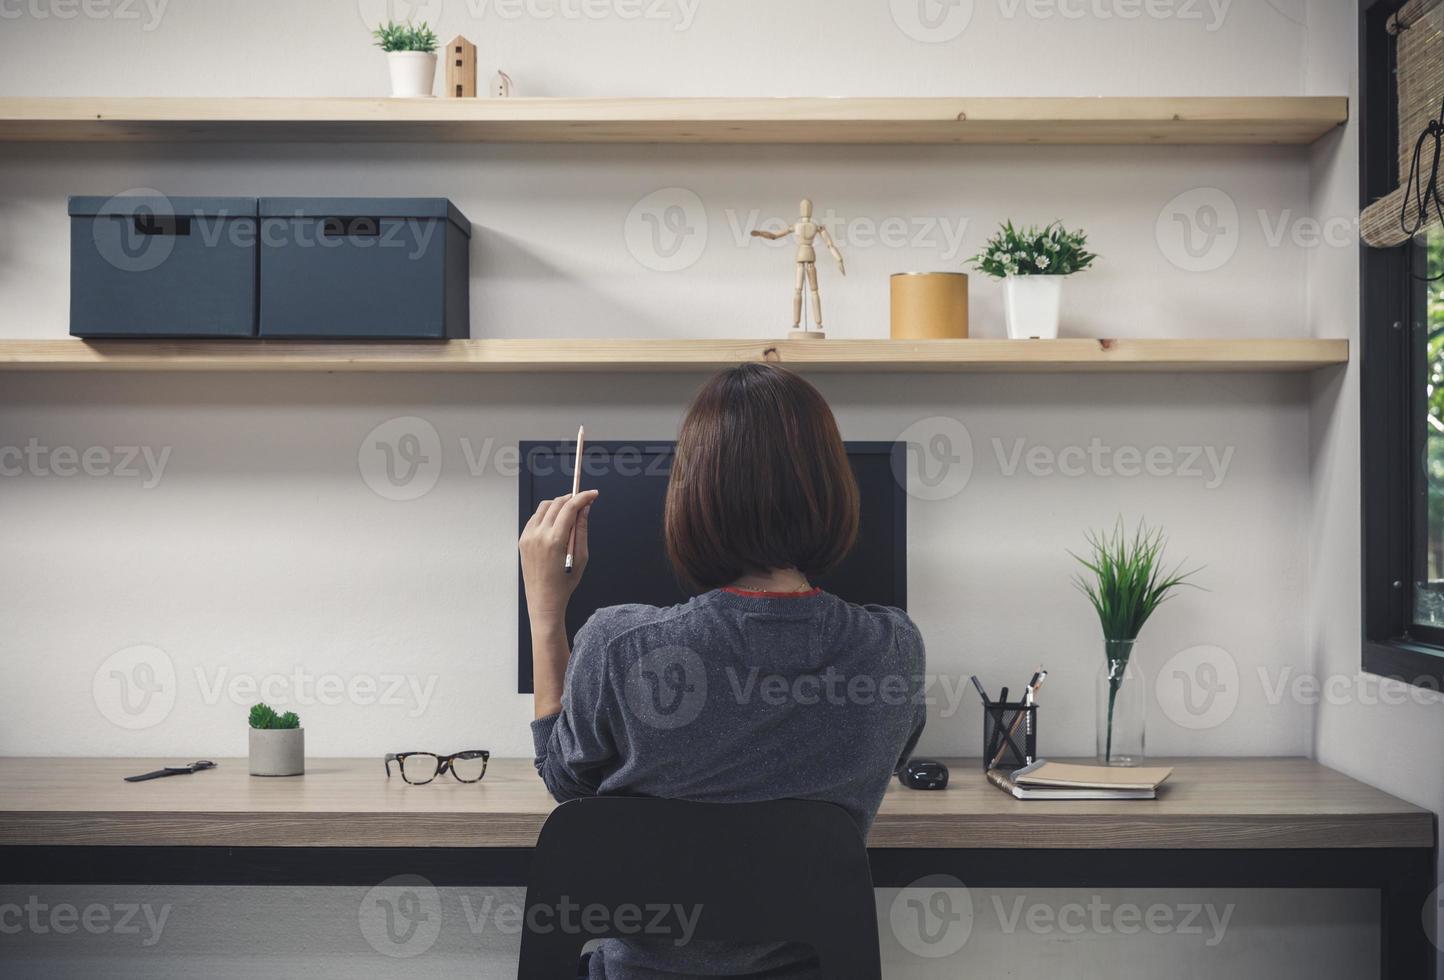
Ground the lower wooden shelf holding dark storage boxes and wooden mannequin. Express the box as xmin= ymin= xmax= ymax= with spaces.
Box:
xmin=0 ymin=339 xmax=1349 ymax=374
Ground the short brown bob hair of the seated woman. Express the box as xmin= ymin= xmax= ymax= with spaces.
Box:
xmin=666 ymin=362 xmax=858 ymax=589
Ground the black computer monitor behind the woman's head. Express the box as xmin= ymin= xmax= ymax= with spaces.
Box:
xmin=517 ymin=442 xmax=907 ymax=694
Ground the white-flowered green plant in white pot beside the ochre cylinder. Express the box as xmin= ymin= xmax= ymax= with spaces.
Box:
xmin=972 ymin=221 xmax=1097 ymax=341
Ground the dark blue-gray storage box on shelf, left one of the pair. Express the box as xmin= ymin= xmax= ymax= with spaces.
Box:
xmin=69 ymin=195 xmax=257 ymax=338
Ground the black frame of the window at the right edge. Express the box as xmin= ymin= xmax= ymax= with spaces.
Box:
xmin=1359 ymin=0 xmax=1444 ymax=690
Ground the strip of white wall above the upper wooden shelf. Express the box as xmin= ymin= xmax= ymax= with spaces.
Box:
xmin=0 ymin=0 xmax=1305 ymax=97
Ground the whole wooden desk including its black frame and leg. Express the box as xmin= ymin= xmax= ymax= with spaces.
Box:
xmin=0 ymin=759 xmax=1437 ymax=980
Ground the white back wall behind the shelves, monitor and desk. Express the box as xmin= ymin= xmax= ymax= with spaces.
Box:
xmin=0 ymin=0 xmax=1440 ymax=979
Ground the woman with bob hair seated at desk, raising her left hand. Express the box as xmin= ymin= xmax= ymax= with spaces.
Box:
xmin=520 ymin=364 xmax=926 ymax=980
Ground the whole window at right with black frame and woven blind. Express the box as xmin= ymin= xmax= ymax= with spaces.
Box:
xmin=1359 ymin=0 xmax=1444 ymax=690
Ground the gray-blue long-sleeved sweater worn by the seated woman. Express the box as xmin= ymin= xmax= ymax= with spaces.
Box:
xmin=531 ymin=589 xmax=926 ymax=980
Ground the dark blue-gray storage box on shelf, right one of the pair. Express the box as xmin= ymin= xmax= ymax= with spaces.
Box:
xmin=260 ymin=198 xmax=471 ymax=341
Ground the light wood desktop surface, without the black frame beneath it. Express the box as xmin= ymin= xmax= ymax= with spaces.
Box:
xmin=0 ymin=759 xmax=1434 ymax=850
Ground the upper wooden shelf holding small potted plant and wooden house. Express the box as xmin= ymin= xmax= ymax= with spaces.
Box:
xmin=0 ymin=95 xmax=1349 ymax=144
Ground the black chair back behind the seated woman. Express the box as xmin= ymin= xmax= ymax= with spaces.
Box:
xmin=517 ymin=797 xmax=882 ymax=980
